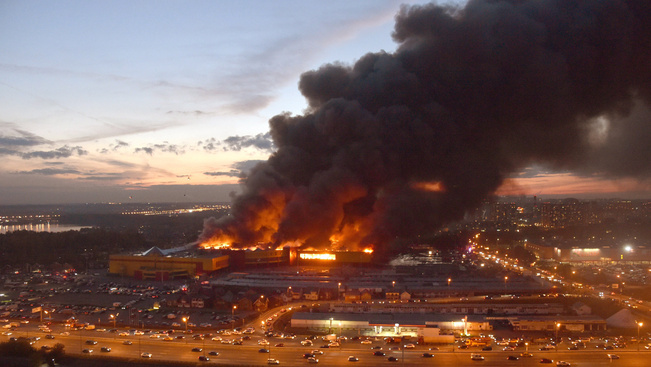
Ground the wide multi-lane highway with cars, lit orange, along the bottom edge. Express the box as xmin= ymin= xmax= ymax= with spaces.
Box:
xmin=0 ymin=325 xmax=651 ymax=367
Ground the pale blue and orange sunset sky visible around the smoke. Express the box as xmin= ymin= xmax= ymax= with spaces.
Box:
xmin=0 ymin=0 xmax=651 ymax=205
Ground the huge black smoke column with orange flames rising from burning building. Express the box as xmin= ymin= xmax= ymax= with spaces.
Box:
xmin=201 ymin=0 xmax=651 ymax=258
